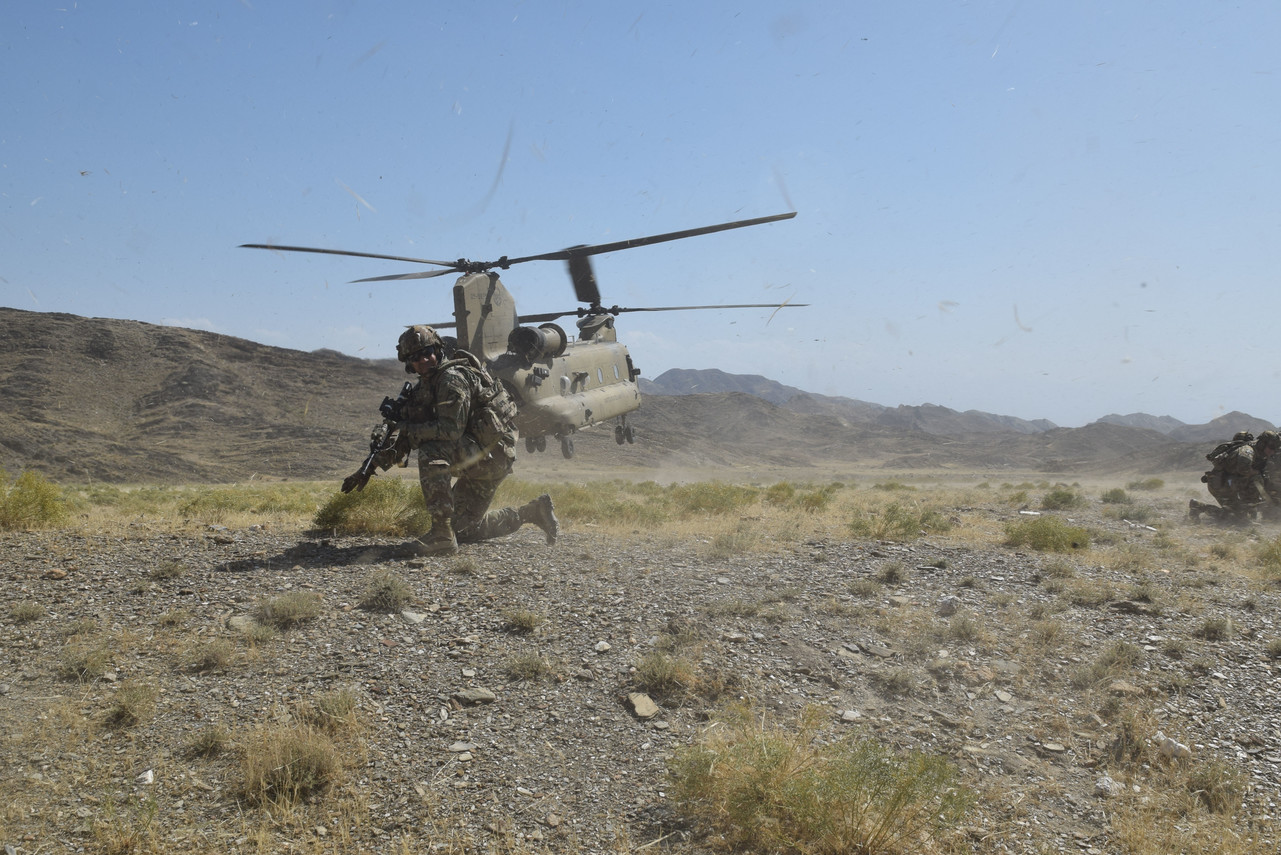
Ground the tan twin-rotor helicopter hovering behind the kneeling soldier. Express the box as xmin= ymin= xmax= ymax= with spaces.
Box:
xmin=242 ymin=212 xmax=808 ymax=458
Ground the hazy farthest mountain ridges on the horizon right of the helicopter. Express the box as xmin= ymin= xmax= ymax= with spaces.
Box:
xmin=641 ymin=368 xmax=1272 ymax=442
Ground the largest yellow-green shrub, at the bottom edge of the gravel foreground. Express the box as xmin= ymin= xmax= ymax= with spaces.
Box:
xmin=670 ymin=714 xmax=974 ymax=855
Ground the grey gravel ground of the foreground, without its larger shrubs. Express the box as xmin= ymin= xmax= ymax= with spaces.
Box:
xmin=0 ymin=497 xmax=1281 ymax=854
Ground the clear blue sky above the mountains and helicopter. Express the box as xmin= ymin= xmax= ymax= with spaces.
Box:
xmin=0 ymin=0 xmax=1281 ymax=426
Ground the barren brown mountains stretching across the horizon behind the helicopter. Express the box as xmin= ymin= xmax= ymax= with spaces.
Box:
xmin=0 ymin=308 xmax=1271 ymax=483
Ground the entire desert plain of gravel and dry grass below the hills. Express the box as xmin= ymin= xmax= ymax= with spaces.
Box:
xmin=0 ymin=465 xmax=1281 ymax=855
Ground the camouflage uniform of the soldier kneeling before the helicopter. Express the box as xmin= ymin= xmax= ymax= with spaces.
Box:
xmin=397 ymin=360 xmax=521 ymax=544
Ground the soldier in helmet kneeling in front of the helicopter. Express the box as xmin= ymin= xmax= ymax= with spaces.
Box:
xmin=343 ymin=324 xmax=560 ymax=555
